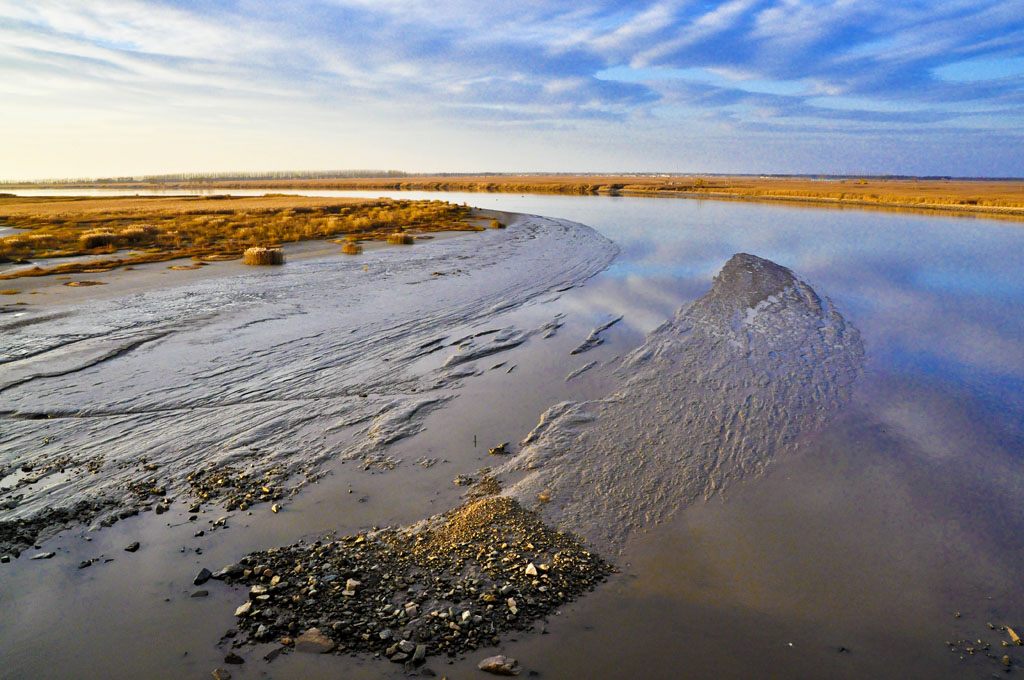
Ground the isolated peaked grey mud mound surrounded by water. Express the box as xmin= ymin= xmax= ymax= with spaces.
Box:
xmin=499 ymin=254 xmax=863 ymax=552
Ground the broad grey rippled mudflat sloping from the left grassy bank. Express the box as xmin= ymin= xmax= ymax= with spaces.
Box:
xmin=0 ymin=217 xmax=616 ymax=549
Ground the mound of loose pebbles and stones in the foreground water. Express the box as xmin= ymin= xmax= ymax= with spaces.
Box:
xmin=218 ymin=497 xmax=611 ymax=668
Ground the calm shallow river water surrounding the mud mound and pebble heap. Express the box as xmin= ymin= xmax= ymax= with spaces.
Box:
xmin=0 ymin=192 xmax=1024 ymax=678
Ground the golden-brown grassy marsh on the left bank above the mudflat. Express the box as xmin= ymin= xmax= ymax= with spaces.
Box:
xmin=0 ymin=196 xmax=471 ymax=279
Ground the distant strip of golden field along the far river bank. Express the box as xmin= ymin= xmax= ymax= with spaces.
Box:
xmin=6 ymin=175 xmax=1024 ymax=218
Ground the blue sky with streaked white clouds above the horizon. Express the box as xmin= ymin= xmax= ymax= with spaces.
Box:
xmin=0 ymin=0 xmax=1024 ymax=179
